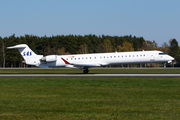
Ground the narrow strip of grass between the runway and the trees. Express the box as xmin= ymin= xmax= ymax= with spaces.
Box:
xmin=0 ymin=68 xmax=180 ymax=73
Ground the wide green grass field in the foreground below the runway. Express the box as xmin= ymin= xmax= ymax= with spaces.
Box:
xmin=0 ymin=77 xmax=180 ymax=120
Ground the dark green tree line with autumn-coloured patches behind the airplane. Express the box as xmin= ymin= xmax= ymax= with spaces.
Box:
xmin=0 ymin=34 xmax=179 ymax=67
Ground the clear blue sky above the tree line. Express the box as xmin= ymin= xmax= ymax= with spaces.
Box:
xmin=0 ymin=0 xmax=180 ymax=46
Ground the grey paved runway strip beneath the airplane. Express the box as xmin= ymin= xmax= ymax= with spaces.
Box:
xmin=0 ymin=73 xmax=180 ymax=77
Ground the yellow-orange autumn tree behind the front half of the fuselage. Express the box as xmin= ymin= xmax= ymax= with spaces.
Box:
xmin=117 ymin=41 xmax=134 ymax=52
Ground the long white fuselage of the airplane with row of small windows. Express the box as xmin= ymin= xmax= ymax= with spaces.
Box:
xmin=39 ymin=51 xmax=174 ymax=68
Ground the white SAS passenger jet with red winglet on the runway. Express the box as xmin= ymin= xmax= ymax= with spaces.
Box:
xmin=8 ymin=44 xmax=174 ymax=74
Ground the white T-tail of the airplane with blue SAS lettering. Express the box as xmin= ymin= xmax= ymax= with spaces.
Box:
xmin=8 ymin=44 xmax=43 ymax=66
